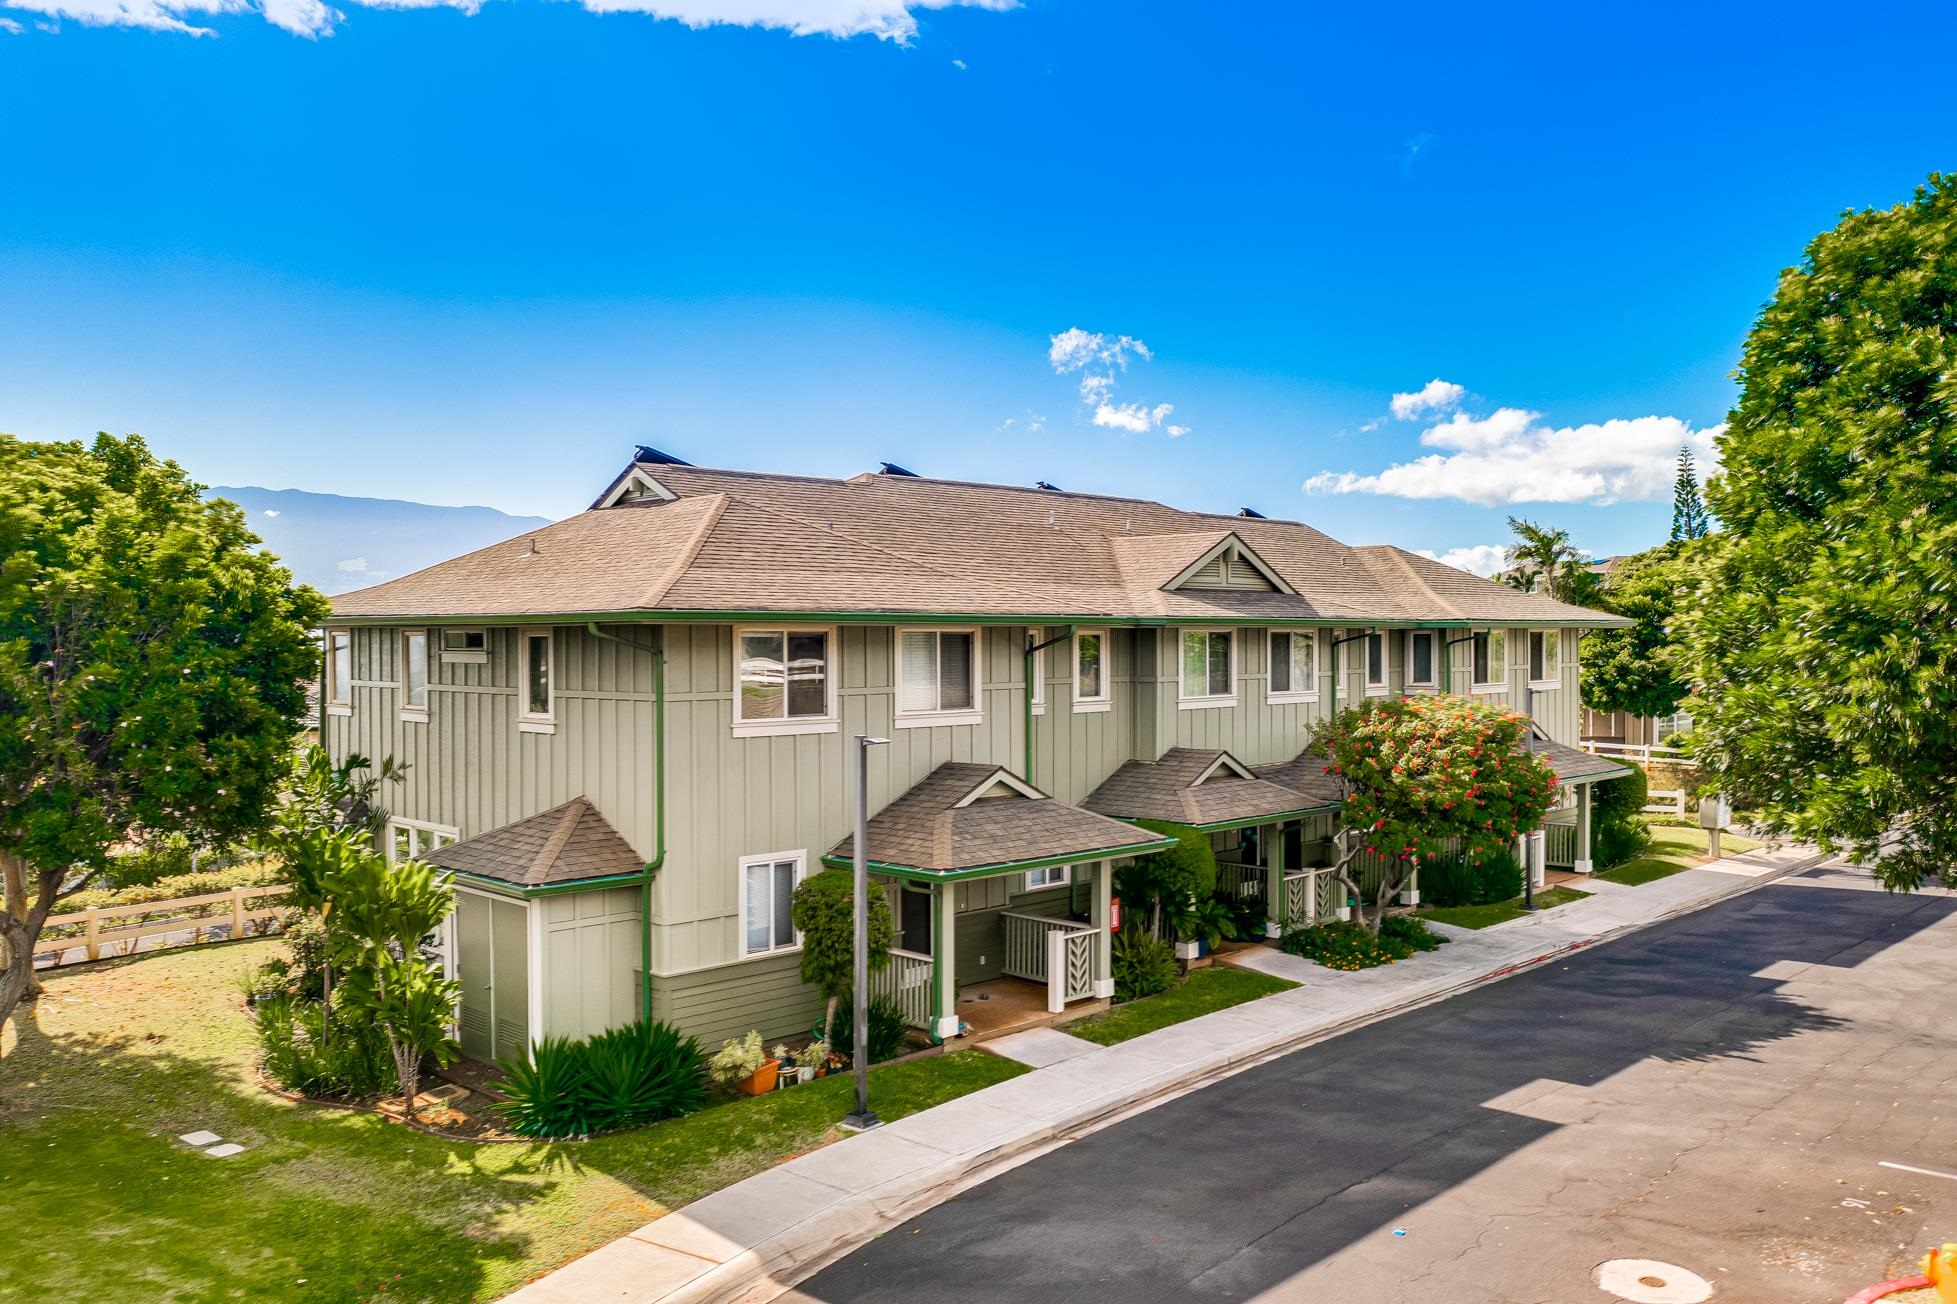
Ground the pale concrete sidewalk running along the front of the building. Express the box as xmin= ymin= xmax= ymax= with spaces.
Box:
xmin=509 ymin=848 xmax=1820 ymax=1304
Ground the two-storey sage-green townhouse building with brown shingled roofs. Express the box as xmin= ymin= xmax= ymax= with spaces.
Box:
xmin=323 ymin=450 xmax=1622 ymax=1057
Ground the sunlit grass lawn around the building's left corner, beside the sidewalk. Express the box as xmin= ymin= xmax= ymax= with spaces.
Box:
xmin=0 ymin=940 xmax=1025 ymax=1302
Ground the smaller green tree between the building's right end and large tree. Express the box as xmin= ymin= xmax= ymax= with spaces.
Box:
xmin=1583 ymin=542 xmax=1695 ymax=715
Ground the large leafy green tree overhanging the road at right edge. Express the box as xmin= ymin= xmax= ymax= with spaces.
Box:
xmin=1683 ymin=176 xmax=1957 ymax=889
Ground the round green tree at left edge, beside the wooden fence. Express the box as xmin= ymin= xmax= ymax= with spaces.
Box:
xmin=0 ymin=435 xmax=327 ymax=1022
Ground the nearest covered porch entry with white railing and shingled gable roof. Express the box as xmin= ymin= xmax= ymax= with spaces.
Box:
xmin=824 ymin=762 xmax=1170 ymax=1042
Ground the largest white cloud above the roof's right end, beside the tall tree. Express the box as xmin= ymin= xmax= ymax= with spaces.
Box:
xmin=1303 ymin=386 xmax=1726 ymax=507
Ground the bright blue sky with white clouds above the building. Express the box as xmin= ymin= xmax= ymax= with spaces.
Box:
xmin=0 ymin=0 xmax=1957 ymax=567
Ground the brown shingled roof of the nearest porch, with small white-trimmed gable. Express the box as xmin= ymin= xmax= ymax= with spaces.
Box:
xmin=830 ymin=762 xmax=1159 ymax=873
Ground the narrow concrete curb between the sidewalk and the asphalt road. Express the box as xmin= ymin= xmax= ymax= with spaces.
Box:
xmin=602 ymin=852 xmax=1828 ymax=1304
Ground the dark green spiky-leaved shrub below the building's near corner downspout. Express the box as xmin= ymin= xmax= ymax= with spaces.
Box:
xmin=495 ymin=1022 xmax=712 ymax=1138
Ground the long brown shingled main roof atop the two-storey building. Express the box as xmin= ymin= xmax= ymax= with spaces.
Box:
xmin=335 ymin=464 xmax=1620 ymax=627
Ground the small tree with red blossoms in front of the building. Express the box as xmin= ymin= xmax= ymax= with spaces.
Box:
xmin=1311 ymin=697 xmax=1556 ymax=932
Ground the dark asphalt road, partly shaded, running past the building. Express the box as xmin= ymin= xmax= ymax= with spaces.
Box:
xmin=791 ymin=869 xmax=1957 ymax=1304
